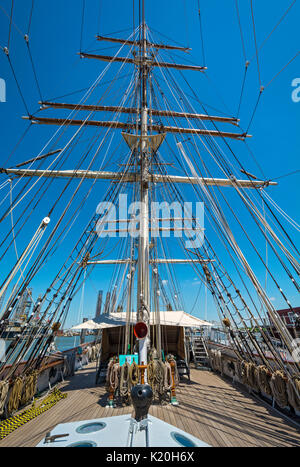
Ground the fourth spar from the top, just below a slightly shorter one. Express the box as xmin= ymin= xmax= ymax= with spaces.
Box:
xmin=23 ymin=116 xmax=251 ymax=141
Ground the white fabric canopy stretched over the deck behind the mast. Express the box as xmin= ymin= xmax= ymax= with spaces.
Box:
xmin=71 ymin=311 xmax=212 ymax=330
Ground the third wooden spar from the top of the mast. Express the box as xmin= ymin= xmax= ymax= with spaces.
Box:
xmin=39 ymin=102 xmax=239 ymax=125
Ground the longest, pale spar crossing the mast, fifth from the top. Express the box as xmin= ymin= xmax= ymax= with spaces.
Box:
xmin=0 ymin=168 xmax=277 ymax=188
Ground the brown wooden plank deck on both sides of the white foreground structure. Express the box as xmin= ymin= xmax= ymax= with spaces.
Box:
xmin=0 ymin=364 xmax=300 ymax=447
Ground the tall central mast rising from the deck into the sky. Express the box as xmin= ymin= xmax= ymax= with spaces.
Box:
xmin=137 ymin=0 xmax=150 ymax=364
